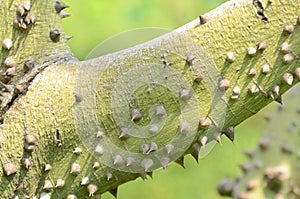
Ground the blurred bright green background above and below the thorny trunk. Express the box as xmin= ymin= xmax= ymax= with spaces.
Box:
xmin=63 ymin=0 xmax=270 ymax=199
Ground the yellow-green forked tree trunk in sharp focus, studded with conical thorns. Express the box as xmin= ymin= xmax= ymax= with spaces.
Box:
xmin=0 ymin=0 xmax=300 ymax=198
